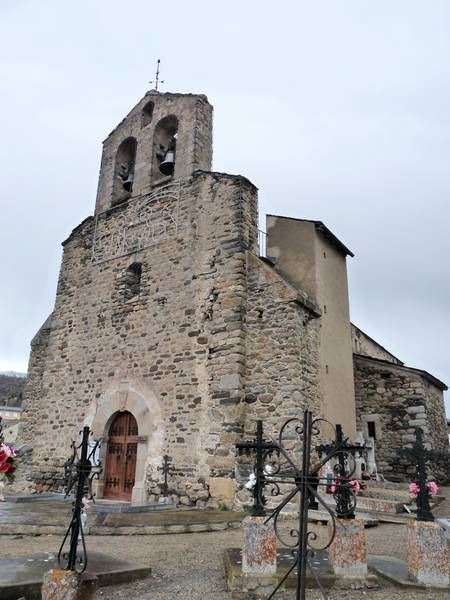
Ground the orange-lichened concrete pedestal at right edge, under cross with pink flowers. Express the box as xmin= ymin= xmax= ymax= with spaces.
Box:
xmin=406 ymin=521 xmax=450 ymax=586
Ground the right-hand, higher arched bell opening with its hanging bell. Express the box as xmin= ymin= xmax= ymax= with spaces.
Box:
xmin=152 ymin=115 xmax=178 ymax=181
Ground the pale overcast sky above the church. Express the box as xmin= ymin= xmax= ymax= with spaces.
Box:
xmin=0 ymin=0 xmax=450 ymax=415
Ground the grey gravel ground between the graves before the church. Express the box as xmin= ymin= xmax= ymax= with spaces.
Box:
xmin=0 ymin=487 xmax=450 ymax=600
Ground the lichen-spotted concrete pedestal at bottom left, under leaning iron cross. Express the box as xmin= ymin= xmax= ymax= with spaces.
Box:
xmin=42 ymin=569 xmax=97 ymax=600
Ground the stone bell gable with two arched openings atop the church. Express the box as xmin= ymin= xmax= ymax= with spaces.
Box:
xmin=95 ymin=90 xmax=212 ymax=214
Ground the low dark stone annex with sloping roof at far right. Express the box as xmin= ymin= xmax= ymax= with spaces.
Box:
xmin=354 ymin=355 xmax=449 ymax=483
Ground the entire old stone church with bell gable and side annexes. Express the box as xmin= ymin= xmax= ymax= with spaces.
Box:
xmin=20 ymin=90 xmax=448 ymax=506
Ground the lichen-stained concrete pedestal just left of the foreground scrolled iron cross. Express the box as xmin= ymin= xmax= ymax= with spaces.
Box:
xmin=242 ymin=517 xmax=277 ymax=574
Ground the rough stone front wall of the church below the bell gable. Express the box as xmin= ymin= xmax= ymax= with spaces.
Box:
xmin=21 ymin=171 xmax=258 ymax=504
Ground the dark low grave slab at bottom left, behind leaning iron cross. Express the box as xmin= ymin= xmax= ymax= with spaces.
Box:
xmin=0 ymin=552 xmax=151 ymax=600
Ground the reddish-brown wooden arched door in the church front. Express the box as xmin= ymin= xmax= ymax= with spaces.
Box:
xmin=103 ymin=411 xmax=138 ymax=501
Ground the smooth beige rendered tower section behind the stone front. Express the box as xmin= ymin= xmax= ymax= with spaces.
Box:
xmin=267 ymin=215 xmax=356 ymax=437
